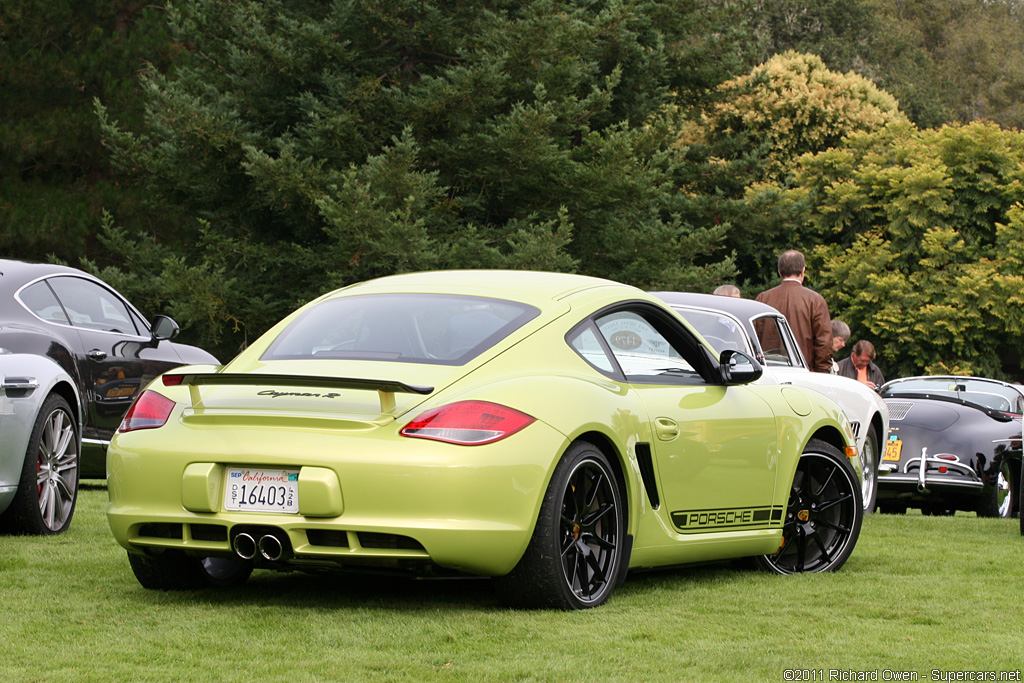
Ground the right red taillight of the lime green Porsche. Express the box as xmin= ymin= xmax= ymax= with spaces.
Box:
xmin=398 ymin=400 xmax=535 ymax=445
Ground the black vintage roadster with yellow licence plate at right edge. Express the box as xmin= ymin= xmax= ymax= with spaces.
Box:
xmin=878 ymin=376 xmax=1024 ymax=518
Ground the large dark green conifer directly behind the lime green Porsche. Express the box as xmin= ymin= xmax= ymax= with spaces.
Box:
xmin=97 ymin=0 xmax=741 ymax=355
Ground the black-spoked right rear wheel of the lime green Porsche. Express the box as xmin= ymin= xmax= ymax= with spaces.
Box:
xmin=497 ymin=441 xmax=626 ymax=609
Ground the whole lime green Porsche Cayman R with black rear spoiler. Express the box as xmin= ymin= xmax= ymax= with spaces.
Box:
xmin=108 ymin=270 xmax=862 ymax=609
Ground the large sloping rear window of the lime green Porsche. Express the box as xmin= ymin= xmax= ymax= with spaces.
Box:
xmin=263 ymin=294 xmax=540 ymax=366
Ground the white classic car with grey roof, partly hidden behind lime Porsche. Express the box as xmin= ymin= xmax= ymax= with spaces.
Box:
xmin=652 ymin=292 xmax=889 ymax=512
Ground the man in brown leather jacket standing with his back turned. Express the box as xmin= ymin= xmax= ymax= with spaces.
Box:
xmin=758 ymin=250 xmax=833 ymax=373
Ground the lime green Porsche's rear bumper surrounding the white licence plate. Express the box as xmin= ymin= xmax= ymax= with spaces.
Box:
xmin=108 ymin=422 xmax=565 ymax=575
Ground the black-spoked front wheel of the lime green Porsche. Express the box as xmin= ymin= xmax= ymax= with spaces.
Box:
xmin=757 ymin=439 xmax=864 ymax=573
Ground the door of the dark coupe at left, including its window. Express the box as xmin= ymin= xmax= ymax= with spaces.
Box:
xmin=46 ymin=275 xmax=181 ymax=441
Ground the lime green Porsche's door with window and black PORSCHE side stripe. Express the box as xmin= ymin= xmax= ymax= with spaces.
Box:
xmin=595 ymin=307 xmax=781 ymax=533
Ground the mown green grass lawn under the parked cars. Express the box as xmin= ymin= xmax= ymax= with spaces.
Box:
xmin=0 ymin=485 xmax=1024 ymax=683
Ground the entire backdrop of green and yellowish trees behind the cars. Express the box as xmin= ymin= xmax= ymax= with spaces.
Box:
xmin=6 ymin=0 xmax=1024 ymax=378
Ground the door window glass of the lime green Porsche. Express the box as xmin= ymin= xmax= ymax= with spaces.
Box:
xmin=597 ymin=311 xmax=702 ymax=384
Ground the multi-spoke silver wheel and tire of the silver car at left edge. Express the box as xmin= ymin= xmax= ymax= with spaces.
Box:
xmin=0 ymin=394 xmax=81 ymax=536
